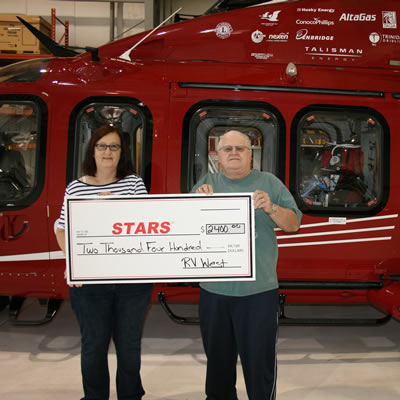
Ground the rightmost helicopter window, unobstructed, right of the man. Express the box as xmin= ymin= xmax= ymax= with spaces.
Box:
xmin=294 ymin=104 xmax=387 ymax=214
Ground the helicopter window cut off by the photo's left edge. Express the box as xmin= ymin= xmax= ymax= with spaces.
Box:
xmin=0 ymin=102 xmax=39 ymax=206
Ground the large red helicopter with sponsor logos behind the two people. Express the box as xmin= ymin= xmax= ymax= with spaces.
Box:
xmin=0 ymin=0 xmax=400 ymax=325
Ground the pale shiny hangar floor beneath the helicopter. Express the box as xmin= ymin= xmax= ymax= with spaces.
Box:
xmin=0 ymin=300 xmax=400 ymax=400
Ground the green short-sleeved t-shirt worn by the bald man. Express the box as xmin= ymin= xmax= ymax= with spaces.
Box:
xmin=192 ymin=170 xmax=302 ymax=296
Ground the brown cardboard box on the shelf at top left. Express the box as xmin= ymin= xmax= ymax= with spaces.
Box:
xmin=0 ymin=14 xmax=51 ymax=54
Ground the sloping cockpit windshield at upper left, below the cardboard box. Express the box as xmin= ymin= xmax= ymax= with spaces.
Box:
xmin=0 ymin=58 xmax=51 ymax=82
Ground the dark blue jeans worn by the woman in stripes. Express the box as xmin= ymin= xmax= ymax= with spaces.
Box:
xmin=69 ymin=284 xmax=153 ymax=400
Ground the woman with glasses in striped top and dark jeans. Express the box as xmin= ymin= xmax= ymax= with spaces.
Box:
xmin=56 ymin=125 xmax=152 ymax=400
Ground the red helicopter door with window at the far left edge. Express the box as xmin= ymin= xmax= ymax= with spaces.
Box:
xmin=0 ymin=96 xmax=49 ymax=297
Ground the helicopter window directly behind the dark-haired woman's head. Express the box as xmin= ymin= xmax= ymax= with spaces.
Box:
xmin=73 ymin=103 xmax=149 ymax=182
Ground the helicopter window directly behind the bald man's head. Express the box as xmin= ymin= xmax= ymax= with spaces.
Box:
xmin=182 ymin=105 xmax=283 ymax=191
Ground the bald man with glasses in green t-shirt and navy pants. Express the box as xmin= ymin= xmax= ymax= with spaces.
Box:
xmin=193 ymin=131 xmax=301 ymax=400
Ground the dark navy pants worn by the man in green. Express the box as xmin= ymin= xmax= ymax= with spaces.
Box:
xmin=200 ymin=289 xmax=278 ymax=400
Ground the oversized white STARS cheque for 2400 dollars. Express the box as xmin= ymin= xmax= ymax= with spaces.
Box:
xmin=65 ymin=193 xmax=255 ymax=283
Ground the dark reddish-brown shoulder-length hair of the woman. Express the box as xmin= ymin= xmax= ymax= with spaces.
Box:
xmin=82 ymin=125 xmax=133 ymax=179
